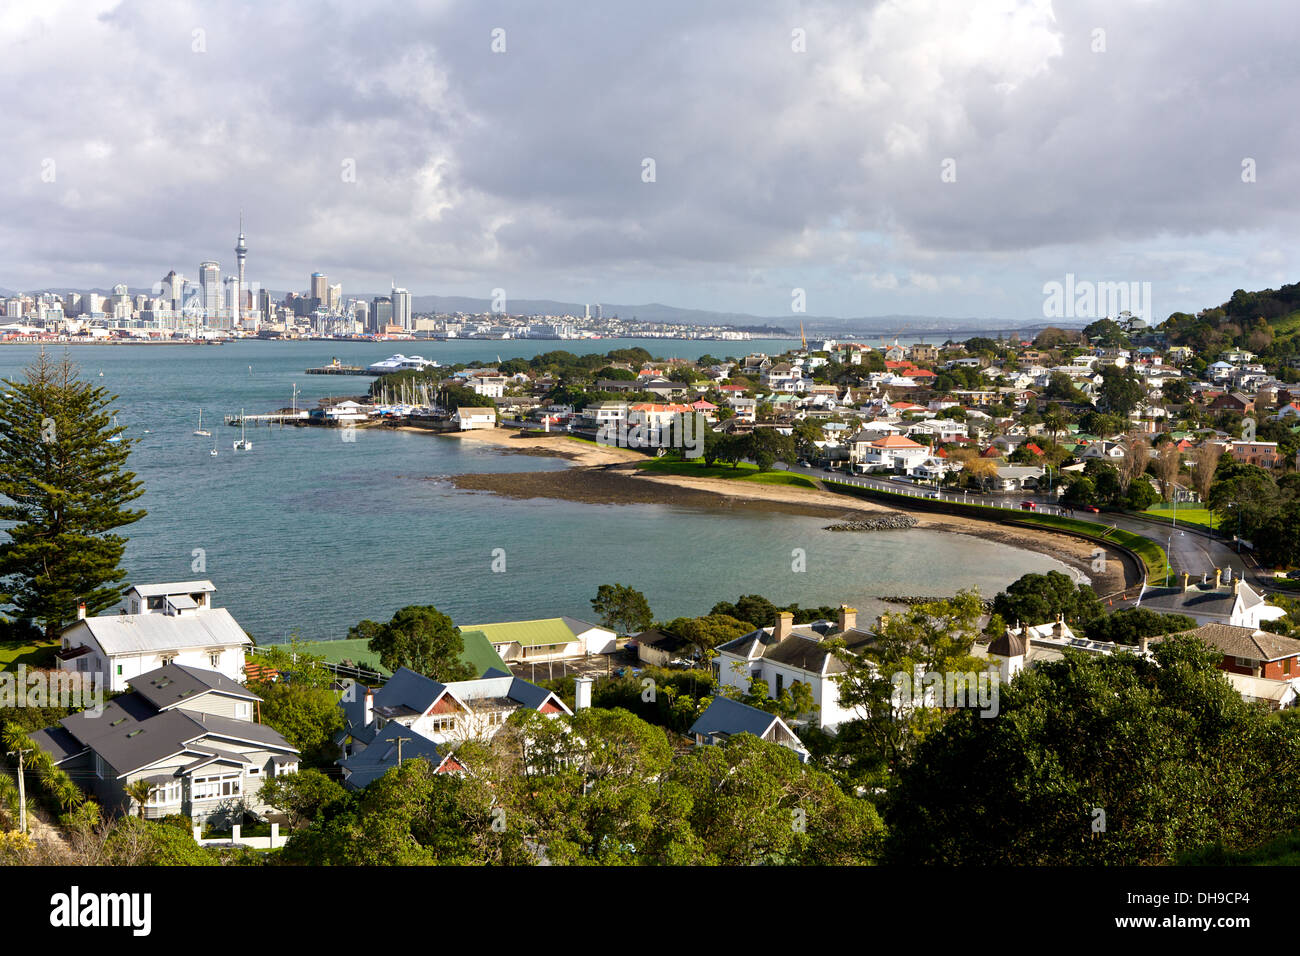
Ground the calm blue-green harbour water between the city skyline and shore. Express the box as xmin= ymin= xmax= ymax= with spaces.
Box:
xmin=0 ymin=339 xmax=1065 ymax=643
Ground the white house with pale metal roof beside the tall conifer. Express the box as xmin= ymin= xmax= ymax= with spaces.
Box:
xmin=57 ymin=581 xmax=252 ymax=693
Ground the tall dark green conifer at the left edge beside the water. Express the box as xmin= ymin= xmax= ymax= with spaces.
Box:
xmin=0 ymin=351 xmax=144 ymax=640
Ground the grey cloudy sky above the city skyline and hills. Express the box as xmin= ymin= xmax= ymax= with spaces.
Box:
xmin=0 ymin=0 xmax=1300 ymax=320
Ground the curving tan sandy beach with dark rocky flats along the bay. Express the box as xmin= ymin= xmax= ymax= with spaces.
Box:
xmin=439 ymin=428 xmax=1126 ymax=594
